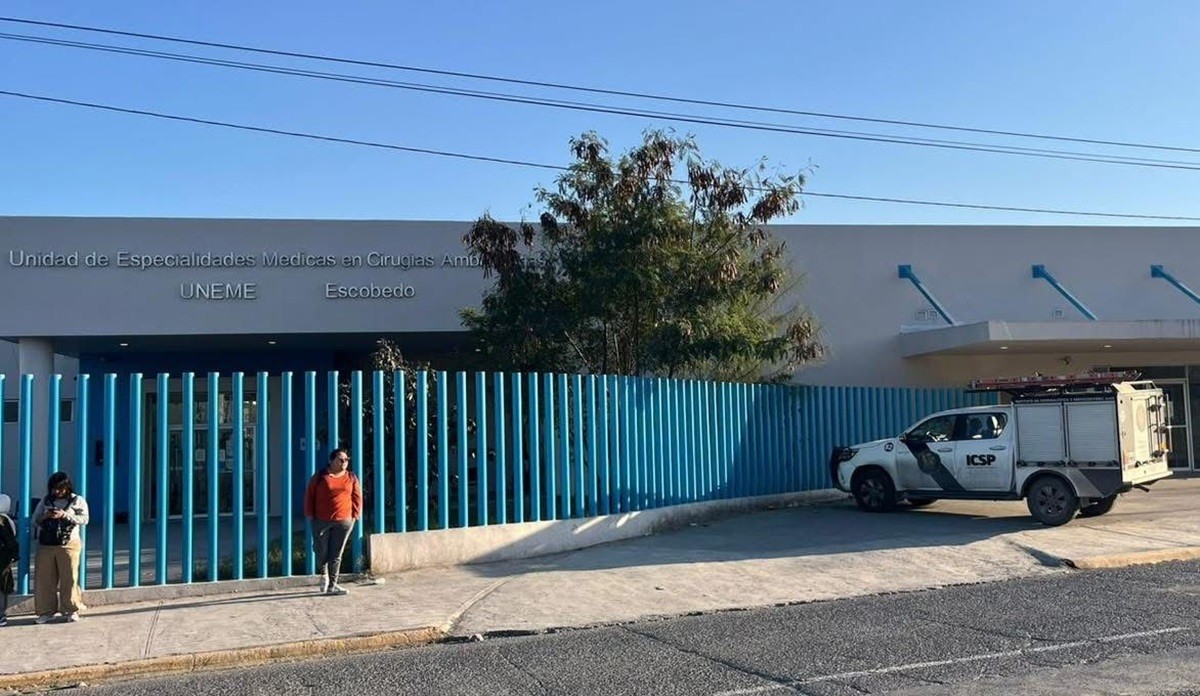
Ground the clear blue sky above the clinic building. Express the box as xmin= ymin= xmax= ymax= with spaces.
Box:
xmin=0 ymin=0 xmax=1200 ymax=224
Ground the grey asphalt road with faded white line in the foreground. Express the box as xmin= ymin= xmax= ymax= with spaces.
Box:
xmin=70 ymin=563 xmax=1200 ymax=696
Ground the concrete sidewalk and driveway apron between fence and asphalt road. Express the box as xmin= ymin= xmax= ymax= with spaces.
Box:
xmin=0 ymin=479 xmax=1200 ymax=690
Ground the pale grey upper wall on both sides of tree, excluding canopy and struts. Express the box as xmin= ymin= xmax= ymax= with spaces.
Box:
xmin=7 ymin=217 xmax=1200 ymax=389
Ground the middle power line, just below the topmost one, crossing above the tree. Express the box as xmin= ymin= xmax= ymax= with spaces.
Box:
xmin=7 ymin=34 xmax=1200 ymax=170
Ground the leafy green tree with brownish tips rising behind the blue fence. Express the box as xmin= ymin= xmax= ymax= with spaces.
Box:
xmin=462 ymin=131 xmax=823 ymax=380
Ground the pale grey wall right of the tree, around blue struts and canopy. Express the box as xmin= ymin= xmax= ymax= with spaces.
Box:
xmin=774 ymin=226 xmax=1200 ymax=385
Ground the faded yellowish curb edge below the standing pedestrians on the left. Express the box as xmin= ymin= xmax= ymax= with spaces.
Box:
xmin=0 ymin=626 xmax=446 ymax=691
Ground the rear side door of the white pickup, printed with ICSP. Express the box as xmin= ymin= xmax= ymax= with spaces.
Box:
xmin=952 ymin=410 xmax=1014 ymax=492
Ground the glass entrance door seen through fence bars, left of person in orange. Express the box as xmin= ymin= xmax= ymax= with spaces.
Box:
xmin=143 ymin=392 xmax=258 ymax=518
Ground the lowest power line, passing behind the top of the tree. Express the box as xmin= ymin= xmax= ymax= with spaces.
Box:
xmin=0 ymin=90 xmax=1200 ymax=222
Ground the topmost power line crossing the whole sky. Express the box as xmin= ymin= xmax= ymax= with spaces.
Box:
xmin=0 ymin=17 xmax=1200 ymax=152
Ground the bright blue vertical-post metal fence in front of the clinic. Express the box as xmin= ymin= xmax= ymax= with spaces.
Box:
xmin=0 ymin=372 xmax=994 ymax=593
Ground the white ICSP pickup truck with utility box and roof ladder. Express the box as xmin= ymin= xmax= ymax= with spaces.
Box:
xmin=829 ymin=376 xmax=1171 ymax=526
